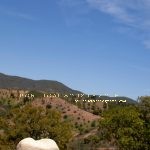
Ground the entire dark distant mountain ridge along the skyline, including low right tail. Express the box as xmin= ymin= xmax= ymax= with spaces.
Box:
xmin=0 ymin=73 xmax=137 ymax=104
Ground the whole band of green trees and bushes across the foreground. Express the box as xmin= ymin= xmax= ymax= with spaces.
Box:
xmin=0 ymin=96 xmax=150 ymax=150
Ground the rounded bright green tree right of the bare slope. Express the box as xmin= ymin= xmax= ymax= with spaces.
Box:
xmin=99 ymin=106 xmax=144 ymax=150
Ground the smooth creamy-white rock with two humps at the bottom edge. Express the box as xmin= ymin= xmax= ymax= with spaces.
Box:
xmin=17 ymin=138 xmax=59 ymax=150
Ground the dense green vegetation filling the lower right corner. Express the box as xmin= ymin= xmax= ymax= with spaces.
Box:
xmin=74 ymin=96 xmax=150 ymax=150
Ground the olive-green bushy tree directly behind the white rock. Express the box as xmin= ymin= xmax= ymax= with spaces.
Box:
xmin=1 ymin=105 xmax=72 ymax=150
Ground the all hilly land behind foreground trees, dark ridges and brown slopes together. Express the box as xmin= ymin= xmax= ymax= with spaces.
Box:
xmin=0 ymin=74 xmax=140 ymax=150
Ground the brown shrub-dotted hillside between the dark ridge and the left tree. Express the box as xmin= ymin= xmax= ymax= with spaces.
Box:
xmin=0 ymin=89 xmax=101 ymax=140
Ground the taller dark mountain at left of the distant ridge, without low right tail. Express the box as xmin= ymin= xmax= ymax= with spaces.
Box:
xmin=0 ymin=73 xmax=82 ymax=94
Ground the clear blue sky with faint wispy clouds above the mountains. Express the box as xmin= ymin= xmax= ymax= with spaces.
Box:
xmin=0 ymin=0 xmax=150 ymax=99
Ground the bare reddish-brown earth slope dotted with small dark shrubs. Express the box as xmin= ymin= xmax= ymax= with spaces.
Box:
xmin=33 ymin=97 xmax=100 ymax=123
